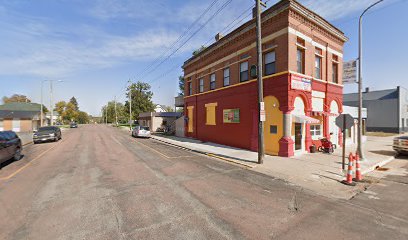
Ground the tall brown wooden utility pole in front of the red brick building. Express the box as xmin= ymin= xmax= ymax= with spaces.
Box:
xmin=255 ymin=0 xmax=266 ymax=164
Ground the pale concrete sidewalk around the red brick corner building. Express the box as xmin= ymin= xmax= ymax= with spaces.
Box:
xmin=152 ymin=135 xmax=395 ymax=199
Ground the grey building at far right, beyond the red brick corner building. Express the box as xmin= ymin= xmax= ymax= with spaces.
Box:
xmin=343 ymin=87 xmax=408 ymax=133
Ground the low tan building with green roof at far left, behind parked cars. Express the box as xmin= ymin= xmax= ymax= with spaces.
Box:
xmin=0 ymin=103 xmax=41 ymax=132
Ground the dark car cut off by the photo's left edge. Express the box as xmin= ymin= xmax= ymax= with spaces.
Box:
xmin=0 ymin=131 xmax=23 ymax=163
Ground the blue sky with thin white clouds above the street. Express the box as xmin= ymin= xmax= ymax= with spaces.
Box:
xmin=0 ymin=0 xmax=408 ymax=115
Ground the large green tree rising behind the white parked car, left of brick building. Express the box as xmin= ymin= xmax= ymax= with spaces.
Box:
xmin=125 ymin=81 xmax=154 ymax=119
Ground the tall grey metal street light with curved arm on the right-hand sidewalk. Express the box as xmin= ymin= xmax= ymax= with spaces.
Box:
xmin=357 ymin=0 xmax=384 ymax=159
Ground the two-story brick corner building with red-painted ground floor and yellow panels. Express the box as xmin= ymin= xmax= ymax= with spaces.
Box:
xmin=183 ymin=0 xmax=347 ymax=156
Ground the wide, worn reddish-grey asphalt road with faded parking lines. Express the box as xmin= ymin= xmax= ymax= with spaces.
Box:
xmin=0 ymin=125 xmax=408 ymax=240
